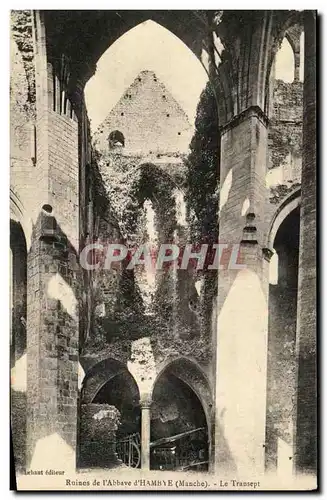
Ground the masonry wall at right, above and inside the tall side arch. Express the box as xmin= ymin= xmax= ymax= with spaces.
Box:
xmin=266 ymin=64 xmax=303 ymax=470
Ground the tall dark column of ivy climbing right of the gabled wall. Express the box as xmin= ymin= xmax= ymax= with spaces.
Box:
xmin=186 ymin=81 xmax=220 ymax=344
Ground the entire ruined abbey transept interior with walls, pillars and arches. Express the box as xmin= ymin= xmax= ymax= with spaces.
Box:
xmin=10 ymin=10 xmax=317 ymax=477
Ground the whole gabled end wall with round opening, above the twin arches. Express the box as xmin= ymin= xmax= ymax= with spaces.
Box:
xmin=81 ymin=78 xmax=218 ymax=406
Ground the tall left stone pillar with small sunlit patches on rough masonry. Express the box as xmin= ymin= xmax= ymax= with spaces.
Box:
xmin=27 ymin=12 xmax=79 ymax=470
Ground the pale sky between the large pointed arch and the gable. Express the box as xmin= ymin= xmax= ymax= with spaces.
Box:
xmin=85 ymin=18 xmax=208 ymax=131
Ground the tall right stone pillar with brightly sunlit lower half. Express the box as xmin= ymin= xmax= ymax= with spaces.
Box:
xmin=215 ymin=106 xmax=268 ymax=476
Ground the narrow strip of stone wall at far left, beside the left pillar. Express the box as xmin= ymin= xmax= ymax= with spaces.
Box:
xmin=10 ymin=11 xmax=36 ymax=470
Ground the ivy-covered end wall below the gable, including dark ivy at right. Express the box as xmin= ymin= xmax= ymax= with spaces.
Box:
xmin=82 ymin=78 xmax=220 ymax=361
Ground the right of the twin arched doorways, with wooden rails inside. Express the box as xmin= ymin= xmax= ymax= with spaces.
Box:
xmin=150 ymin=359 xmax=210 ymax=471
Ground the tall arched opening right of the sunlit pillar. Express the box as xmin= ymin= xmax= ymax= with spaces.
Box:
xmin=266 ymin=202 xmax=300 ymax=475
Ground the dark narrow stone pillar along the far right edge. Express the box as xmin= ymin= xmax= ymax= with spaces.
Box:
xmin=294 ymin=11 xmax=317 ymax=473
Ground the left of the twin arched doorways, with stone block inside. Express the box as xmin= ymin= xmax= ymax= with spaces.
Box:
xmin=79 ymin=359 xmax=141 ymax=468
